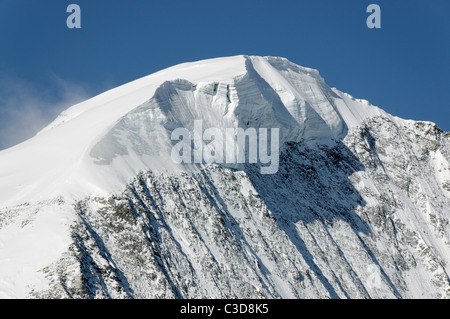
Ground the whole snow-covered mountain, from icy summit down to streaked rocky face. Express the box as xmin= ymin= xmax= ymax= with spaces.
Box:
xmin=0 ymin=55 xmax=450 ymax=298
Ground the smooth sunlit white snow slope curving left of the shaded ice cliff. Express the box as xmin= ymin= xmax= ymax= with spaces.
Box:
xmin=0 ymin=57 xmax=245 ymax=206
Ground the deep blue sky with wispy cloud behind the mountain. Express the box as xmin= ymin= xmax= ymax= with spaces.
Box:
xmin=0 ymin=0 xmax=450 ymax=149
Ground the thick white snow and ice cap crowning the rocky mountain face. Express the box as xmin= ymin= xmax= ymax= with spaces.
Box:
xmin=0 ymin=56 xmax=384 ymax=206
